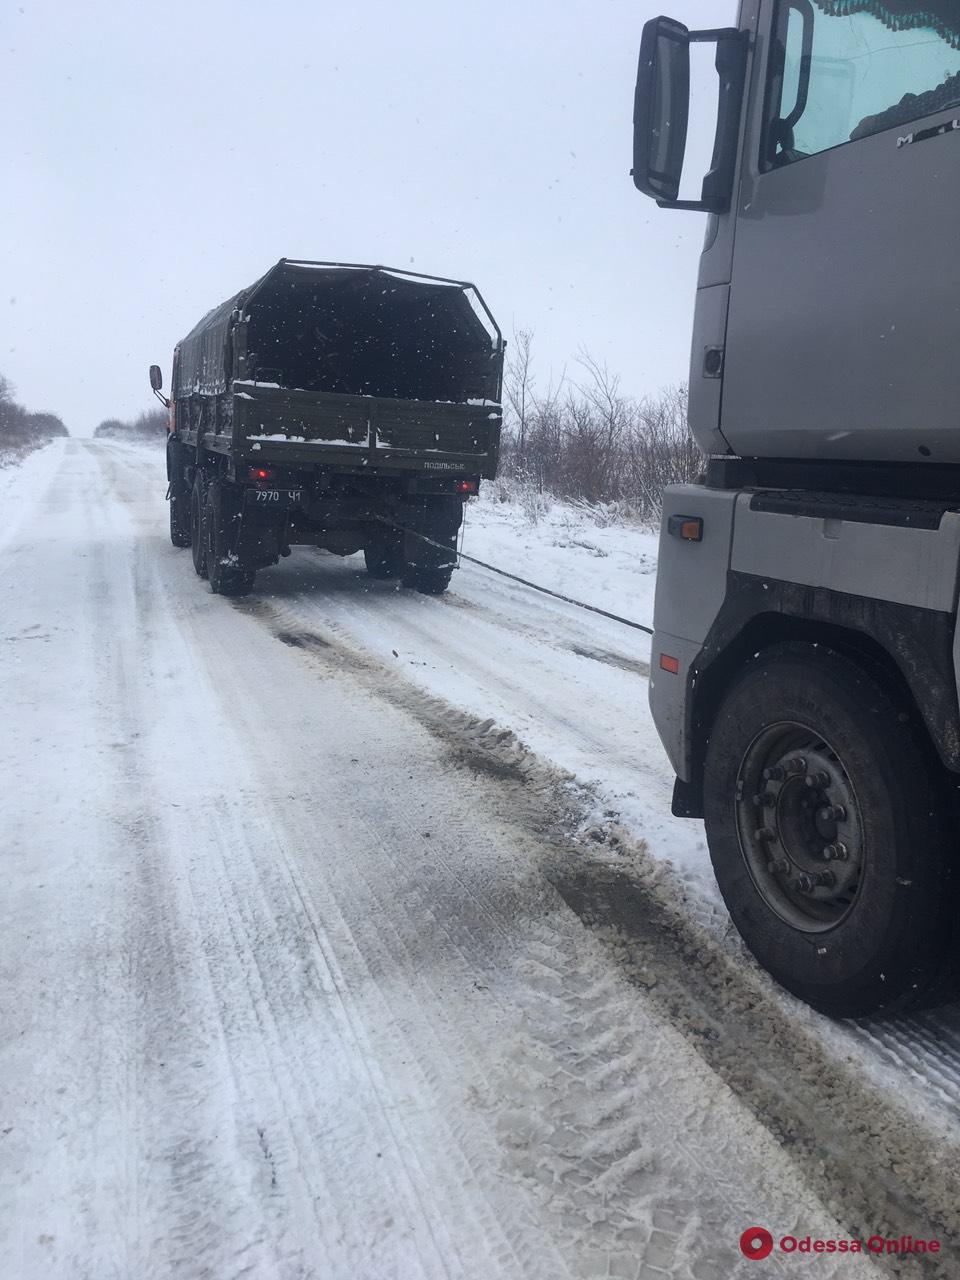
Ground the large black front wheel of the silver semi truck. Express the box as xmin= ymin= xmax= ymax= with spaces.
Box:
xmin=704 ymin=644 xmax=957 ymax=1018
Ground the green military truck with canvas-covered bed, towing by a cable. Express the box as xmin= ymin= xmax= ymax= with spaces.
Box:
xmin=150 ymin=259 xmax=504 ymax=595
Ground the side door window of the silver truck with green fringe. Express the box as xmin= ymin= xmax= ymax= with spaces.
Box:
xmin=764 ymin=0 xmax=960 ymax=168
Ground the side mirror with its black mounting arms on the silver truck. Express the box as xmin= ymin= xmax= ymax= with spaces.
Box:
xmin=631 ymin=18 xmax=748 ymax=214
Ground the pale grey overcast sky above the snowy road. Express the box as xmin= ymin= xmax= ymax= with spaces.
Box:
xmin=0 ymin=0 xmax=736 ymax=434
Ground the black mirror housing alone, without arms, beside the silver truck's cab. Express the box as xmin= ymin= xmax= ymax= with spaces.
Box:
xmin=632 ymin=18 xmax=690 ymax=201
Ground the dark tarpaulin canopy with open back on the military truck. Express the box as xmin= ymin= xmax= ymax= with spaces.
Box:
xmin=174 ymin=259 xmax=503 ymax=403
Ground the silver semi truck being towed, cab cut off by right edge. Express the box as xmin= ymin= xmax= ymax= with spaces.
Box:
xmin=634 ymin=0 xmax=960 ymax=1016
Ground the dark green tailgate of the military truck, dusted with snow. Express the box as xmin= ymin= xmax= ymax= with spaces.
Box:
xmin=233 ymin=383 xmax=502 ymax=479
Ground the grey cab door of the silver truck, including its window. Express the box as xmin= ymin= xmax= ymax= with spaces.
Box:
xmin=721 ymin=0 xmax=960 ymax=463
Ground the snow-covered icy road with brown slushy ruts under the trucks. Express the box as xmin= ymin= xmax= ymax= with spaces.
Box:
xmin=0 ymin=440 xmax=960 ymax=1280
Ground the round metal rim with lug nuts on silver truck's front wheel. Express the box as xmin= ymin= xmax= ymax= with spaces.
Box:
xmin=736 ymin=722 xmax=864 ymax=933
